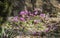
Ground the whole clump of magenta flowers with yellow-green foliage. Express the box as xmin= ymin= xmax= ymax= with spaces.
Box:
xmin=5 ymin=9 xmax=55 ymax=34
